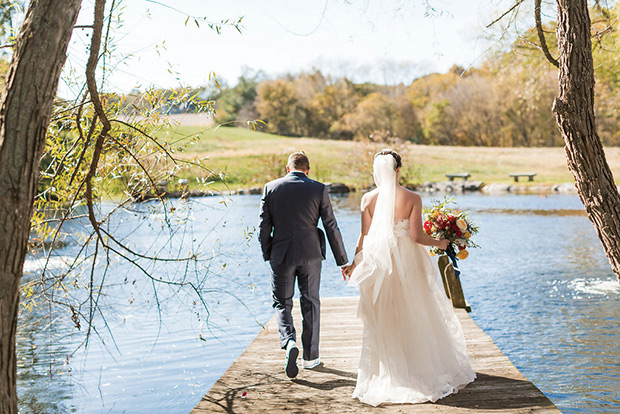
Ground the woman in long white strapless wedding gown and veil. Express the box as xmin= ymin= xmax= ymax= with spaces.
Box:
xmin=343 ymin=150 xmax=476 ymax=406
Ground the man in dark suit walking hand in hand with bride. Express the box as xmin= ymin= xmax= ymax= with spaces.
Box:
xmin=258 ymin=152 xmax=347 ymax=378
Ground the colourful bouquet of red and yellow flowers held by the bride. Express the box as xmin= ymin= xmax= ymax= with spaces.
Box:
xmin=423 ymin=197 xmax=479 ymax=260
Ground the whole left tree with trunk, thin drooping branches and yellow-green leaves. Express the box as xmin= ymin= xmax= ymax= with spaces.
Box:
xmin=0 ymin=0 xmax=235 ymax=414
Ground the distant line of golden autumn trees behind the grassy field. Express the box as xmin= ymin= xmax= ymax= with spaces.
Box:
xmin=147 ymin=7 xmax=620 ymax=147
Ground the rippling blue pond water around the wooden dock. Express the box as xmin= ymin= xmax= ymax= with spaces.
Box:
xmin=18 ymin=194 xmax=620 ymax=413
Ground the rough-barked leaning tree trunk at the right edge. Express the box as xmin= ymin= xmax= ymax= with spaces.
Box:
xmin=553 ymin=0 xmax=620 ymax=280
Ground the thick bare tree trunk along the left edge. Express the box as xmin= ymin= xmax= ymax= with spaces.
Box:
xmin=0 ymin=0 xmax=81 ymax=414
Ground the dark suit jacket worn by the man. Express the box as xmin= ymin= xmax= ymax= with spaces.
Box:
xmin=258 ymin=171 xmax=347 ymax=266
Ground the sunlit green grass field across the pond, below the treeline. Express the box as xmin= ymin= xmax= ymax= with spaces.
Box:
xmin=154 ymin=126 xmax=620 ymax=189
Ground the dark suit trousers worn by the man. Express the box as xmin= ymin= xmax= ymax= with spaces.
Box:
xmin=270 ymin=260 xmax=321 ymax=361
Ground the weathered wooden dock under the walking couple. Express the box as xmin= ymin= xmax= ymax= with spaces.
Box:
xmin=192 ymin=297 xmax=560 ymax=414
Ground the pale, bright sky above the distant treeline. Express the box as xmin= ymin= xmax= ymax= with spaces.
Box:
xmin=61 ymin=0 xmax=512 ymax=95
